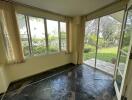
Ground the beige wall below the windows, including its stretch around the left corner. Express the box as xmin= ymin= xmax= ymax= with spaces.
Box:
xmin=0 ymin=53 xmax=72 ymax=93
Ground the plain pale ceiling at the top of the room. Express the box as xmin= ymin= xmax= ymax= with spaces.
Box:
xmin=13 ymin=0 xmax=117 ymax=16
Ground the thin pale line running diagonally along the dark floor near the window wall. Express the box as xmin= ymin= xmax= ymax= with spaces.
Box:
xmin=4 ymin=68 xmax=75 ymax=95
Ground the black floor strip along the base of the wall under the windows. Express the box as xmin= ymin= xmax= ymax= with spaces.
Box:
xmin=7 ymin=64 xmax=75 ymax=92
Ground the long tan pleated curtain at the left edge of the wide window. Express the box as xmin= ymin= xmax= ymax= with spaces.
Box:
xmin=0 ymin=2 xmax=24 ymax=63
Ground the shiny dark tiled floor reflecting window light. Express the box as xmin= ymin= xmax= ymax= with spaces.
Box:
xmin=3 ymin=65 xmax=115 ymax=100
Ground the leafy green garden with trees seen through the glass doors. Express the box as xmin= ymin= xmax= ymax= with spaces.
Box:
xmin=83 ymin=16 xmax=130 ymax=63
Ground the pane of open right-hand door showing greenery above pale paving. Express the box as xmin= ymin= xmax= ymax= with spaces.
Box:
xmin=119 ymin=52 xmax=127 ymax=75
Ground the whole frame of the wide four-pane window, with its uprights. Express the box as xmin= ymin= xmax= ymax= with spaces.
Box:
xmin=16 ymin=13 xmax=69 ymax=59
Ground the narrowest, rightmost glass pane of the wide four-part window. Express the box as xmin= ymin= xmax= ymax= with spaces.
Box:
xmin=60 ymin=22 xmax=67 ymax=51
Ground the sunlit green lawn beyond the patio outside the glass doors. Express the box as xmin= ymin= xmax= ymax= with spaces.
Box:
xmin=84 ymin=47 xmax=117 ymax=62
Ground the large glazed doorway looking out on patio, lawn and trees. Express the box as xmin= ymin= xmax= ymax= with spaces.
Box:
xmin=83 ymin=10 xmax=124 ymax=76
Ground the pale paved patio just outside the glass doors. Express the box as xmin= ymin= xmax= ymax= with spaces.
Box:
xmin=84 ymin=59 xmax=115 ymax=76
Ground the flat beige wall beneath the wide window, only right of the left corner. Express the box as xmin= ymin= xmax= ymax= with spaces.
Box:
xmin=7 ymin=53 xmax=71 ymax=81
